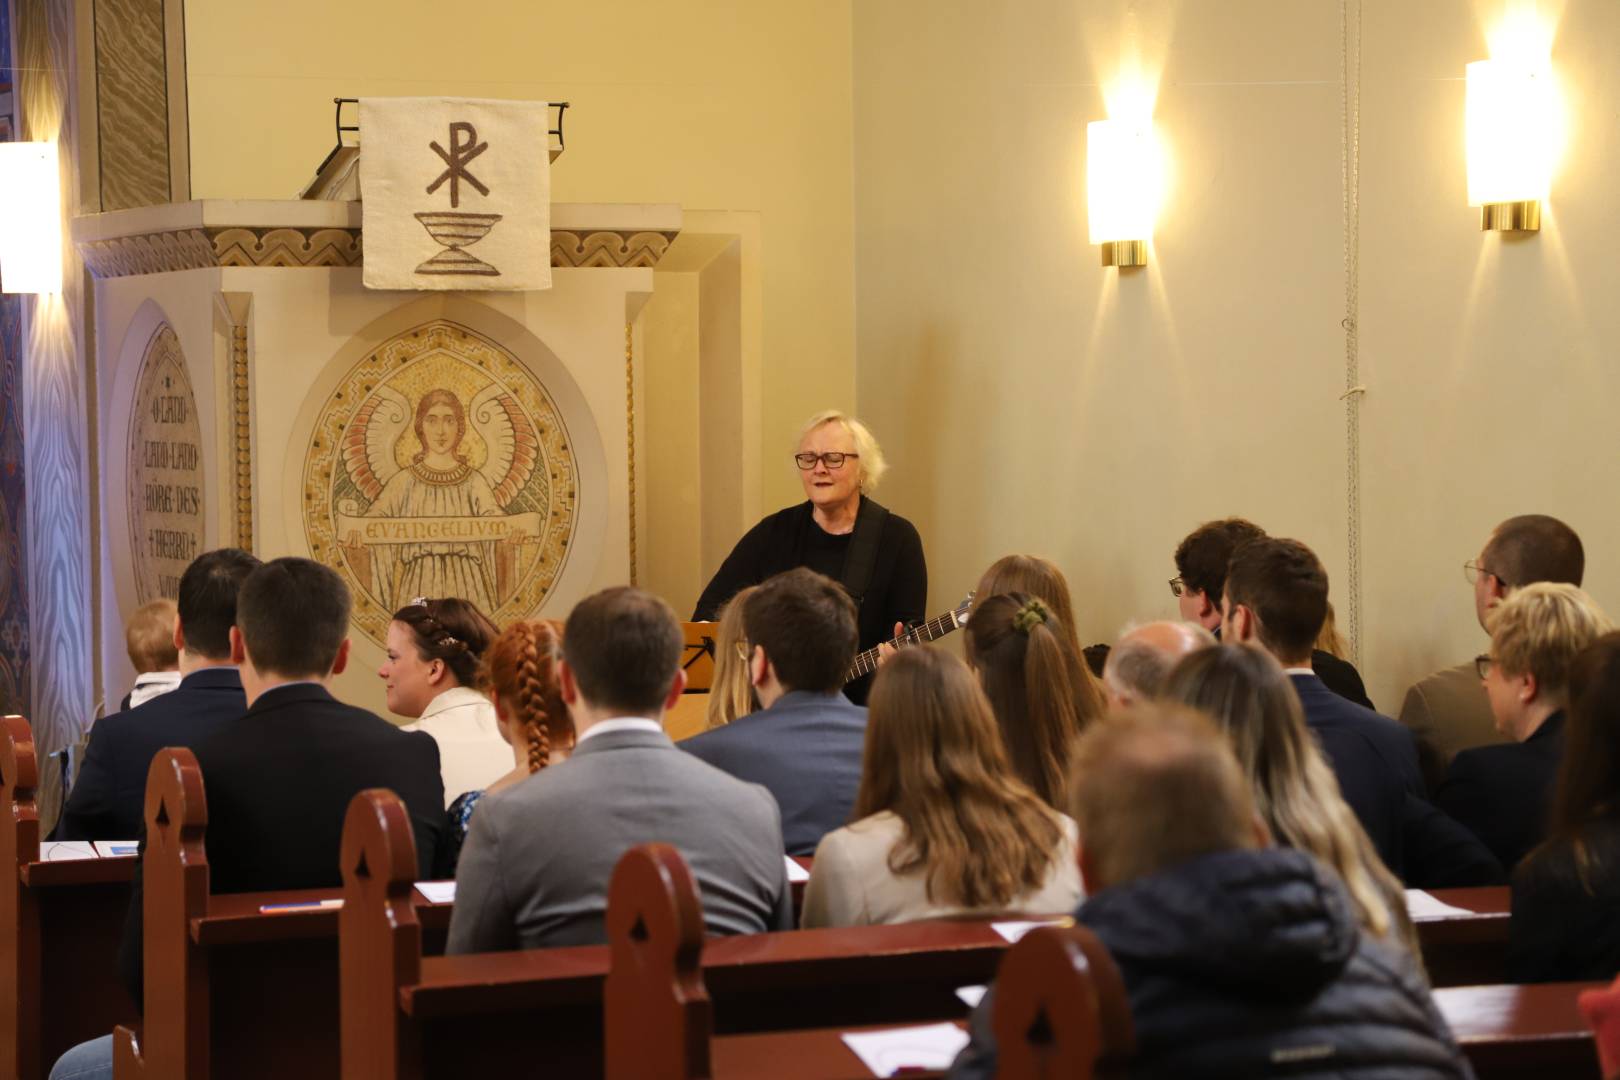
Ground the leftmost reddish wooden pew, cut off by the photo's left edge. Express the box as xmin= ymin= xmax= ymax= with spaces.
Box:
xmin=0 ymin=716 xmax=134 ymax=1080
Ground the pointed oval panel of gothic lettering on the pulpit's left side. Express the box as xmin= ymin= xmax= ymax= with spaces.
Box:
xmin=128 ymin=322 xmax=204 ymax=604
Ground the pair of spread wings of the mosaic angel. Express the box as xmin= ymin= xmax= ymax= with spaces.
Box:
xmin=342 ymin=382 xmax=539 ymax=507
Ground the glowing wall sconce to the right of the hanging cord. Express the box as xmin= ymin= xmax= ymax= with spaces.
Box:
xmin=1468 ymin=57 xmax=1557 ymax=232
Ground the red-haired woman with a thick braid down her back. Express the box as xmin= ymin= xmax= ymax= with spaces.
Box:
xmin=441 ymin=619 xmax=573 ymax=878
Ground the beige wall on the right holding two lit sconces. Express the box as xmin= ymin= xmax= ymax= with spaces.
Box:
xmin=854 ymin=0 xmax=1620 ymax=711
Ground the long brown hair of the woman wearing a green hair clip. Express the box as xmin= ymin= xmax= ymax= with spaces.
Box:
xmin=967 ymin=593 xmax=1103 ymax=811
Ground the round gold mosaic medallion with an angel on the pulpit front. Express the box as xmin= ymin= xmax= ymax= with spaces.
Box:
xmin=303 ymin=319 xmax=578 ymax=644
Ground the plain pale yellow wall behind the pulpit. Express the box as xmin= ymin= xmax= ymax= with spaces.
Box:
xmin=186 ymin=0 xmax=855 ymax=538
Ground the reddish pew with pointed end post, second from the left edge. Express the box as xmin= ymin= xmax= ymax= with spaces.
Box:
xmin=113 ymin=748 xmax=449 ymax=1080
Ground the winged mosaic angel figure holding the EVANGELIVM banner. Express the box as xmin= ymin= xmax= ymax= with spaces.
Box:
xmin=342 ymin=384 xmax=539 ymax=614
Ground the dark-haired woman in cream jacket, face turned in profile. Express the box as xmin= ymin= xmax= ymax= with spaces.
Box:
xmin=377 ymin=596 xmax=509 ymax=806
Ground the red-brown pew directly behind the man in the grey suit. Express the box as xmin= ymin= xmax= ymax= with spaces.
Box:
xmin=342 ymin=792 xmax=1008 ymax=1078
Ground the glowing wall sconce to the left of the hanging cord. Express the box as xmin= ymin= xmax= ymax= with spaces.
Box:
xmin=1085 ymin=117 xmax=1162 ymax=269
